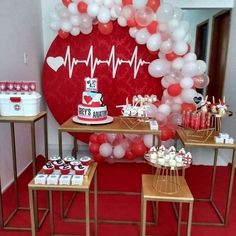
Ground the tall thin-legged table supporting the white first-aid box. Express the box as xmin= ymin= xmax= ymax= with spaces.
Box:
xmin=0 ymin=111 xmax=48 ymax=230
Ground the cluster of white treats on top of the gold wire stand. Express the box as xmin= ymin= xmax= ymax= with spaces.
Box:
xmin=146 ymin=146 xmax=192 ymax=169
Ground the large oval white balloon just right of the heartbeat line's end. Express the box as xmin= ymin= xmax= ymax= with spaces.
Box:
xmin=148 ymin=59 xmax=170 ymax=78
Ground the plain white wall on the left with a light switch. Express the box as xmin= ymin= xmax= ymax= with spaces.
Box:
xmin=0 ymin=0 xmax=43 ymax=191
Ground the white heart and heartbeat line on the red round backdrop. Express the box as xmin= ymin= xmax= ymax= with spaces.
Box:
xmin=47 ymin=45 xmax=150 ymax=79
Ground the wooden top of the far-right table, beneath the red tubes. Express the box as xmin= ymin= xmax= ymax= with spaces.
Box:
xmin=177 ymin=128 xmax=236 ymax=149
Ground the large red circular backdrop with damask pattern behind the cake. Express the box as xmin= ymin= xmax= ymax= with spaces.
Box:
xmin=42 ymin=23 xmax=162 ymax=142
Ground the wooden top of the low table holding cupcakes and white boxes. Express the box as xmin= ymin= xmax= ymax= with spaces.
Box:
xmin=28 ymin=162 xmax=97 ymax=192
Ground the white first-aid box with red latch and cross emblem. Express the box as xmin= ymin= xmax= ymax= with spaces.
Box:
xmin=0 ymin=92 xmax=41 ymax=116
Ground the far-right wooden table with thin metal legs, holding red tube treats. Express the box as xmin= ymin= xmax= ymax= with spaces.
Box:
xmin=177 ymin=128 xmax=236 ymax=226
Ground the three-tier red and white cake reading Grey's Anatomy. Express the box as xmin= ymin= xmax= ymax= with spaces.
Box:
xmin=78 ymin=78 xmax=107 ymax=121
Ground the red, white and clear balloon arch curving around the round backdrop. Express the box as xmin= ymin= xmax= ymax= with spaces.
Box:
xmin=47 ymin=0 xmax=209 ymax=159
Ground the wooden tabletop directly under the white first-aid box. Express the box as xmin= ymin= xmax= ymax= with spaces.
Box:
xmin=0 ymin=111 xmax=47 ymax=123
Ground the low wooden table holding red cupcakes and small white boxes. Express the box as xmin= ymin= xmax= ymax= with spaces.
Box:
xmin=28 ymin=162 xmax=97 ymax=236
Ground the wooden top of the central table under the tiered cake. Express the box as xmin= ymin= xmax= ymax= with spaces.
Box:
xmin=58 ymin=116 xmax=160 ymax=135
